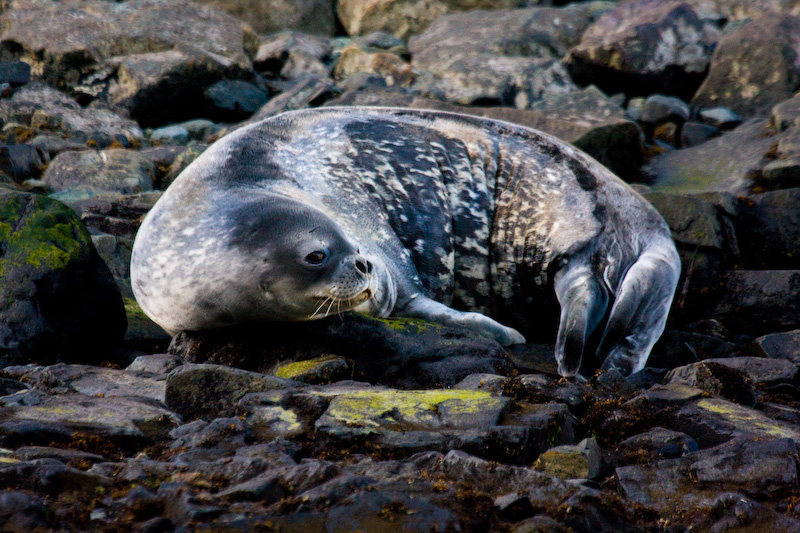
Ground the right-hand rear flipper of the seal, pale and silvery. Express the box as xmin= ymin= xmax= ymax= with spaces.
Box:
xmin=597 ymin=242 xmax=681 ymax=375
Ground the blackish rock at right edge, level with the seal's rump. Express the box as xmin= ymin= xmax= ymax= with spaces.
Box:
xmin=737 ymin=189 xmax=800 ymax=269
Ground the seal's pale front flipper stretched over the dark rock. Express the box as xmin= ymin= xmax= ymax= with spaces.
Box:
xmin=392 ymin=295 xmax=525 ymax=346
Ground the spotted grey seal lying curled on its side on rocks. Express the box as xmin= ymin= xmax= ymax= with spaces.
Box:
xmin=131 ymin=107 xmax=680 ymax=376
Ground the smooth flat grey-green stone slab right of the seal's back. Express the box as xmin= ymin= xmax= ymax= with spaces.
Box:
xmin=642 ymin=119 xmax=779 ymax=195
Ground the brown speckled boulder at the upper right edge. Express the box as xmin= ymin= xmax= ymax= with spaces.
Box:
xmin=692 ymin=14 xmax=800 ymax=118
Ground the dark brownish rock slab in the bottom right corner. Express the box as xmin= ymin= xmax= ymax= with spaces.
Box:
xmin=617 ymin=439 xmax=797 ymax=512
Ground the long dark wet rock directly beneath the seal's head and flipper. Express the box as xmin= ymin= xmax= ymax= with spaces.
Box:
xmin=170 ymin=314 xmax=508 ymax=388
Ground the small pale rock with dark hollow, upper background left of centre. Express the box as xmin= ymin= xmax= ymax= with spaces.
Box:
xmin=253 ymin=31 xmax=333 ymax=79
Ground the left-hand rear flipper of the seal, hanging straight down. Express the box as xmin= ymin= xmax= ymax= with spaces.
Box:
xmin=555 ymin=264 xmax=608 ymax=376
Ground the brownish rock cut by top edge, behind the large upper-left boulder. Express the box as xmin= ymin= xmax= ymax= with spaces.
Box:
xmin=199 ymin=0 xmax=336 ymax=36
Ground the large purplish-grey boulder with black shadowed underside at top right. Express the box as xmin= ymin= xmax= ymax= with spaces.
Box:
xmin=566 ymin=0 xmax=720 ymax=99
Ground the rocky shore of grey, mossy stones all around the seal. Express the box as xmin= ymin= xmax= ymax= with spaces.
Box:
xmin=0 ymin=0 xmax=800 ymax=532
